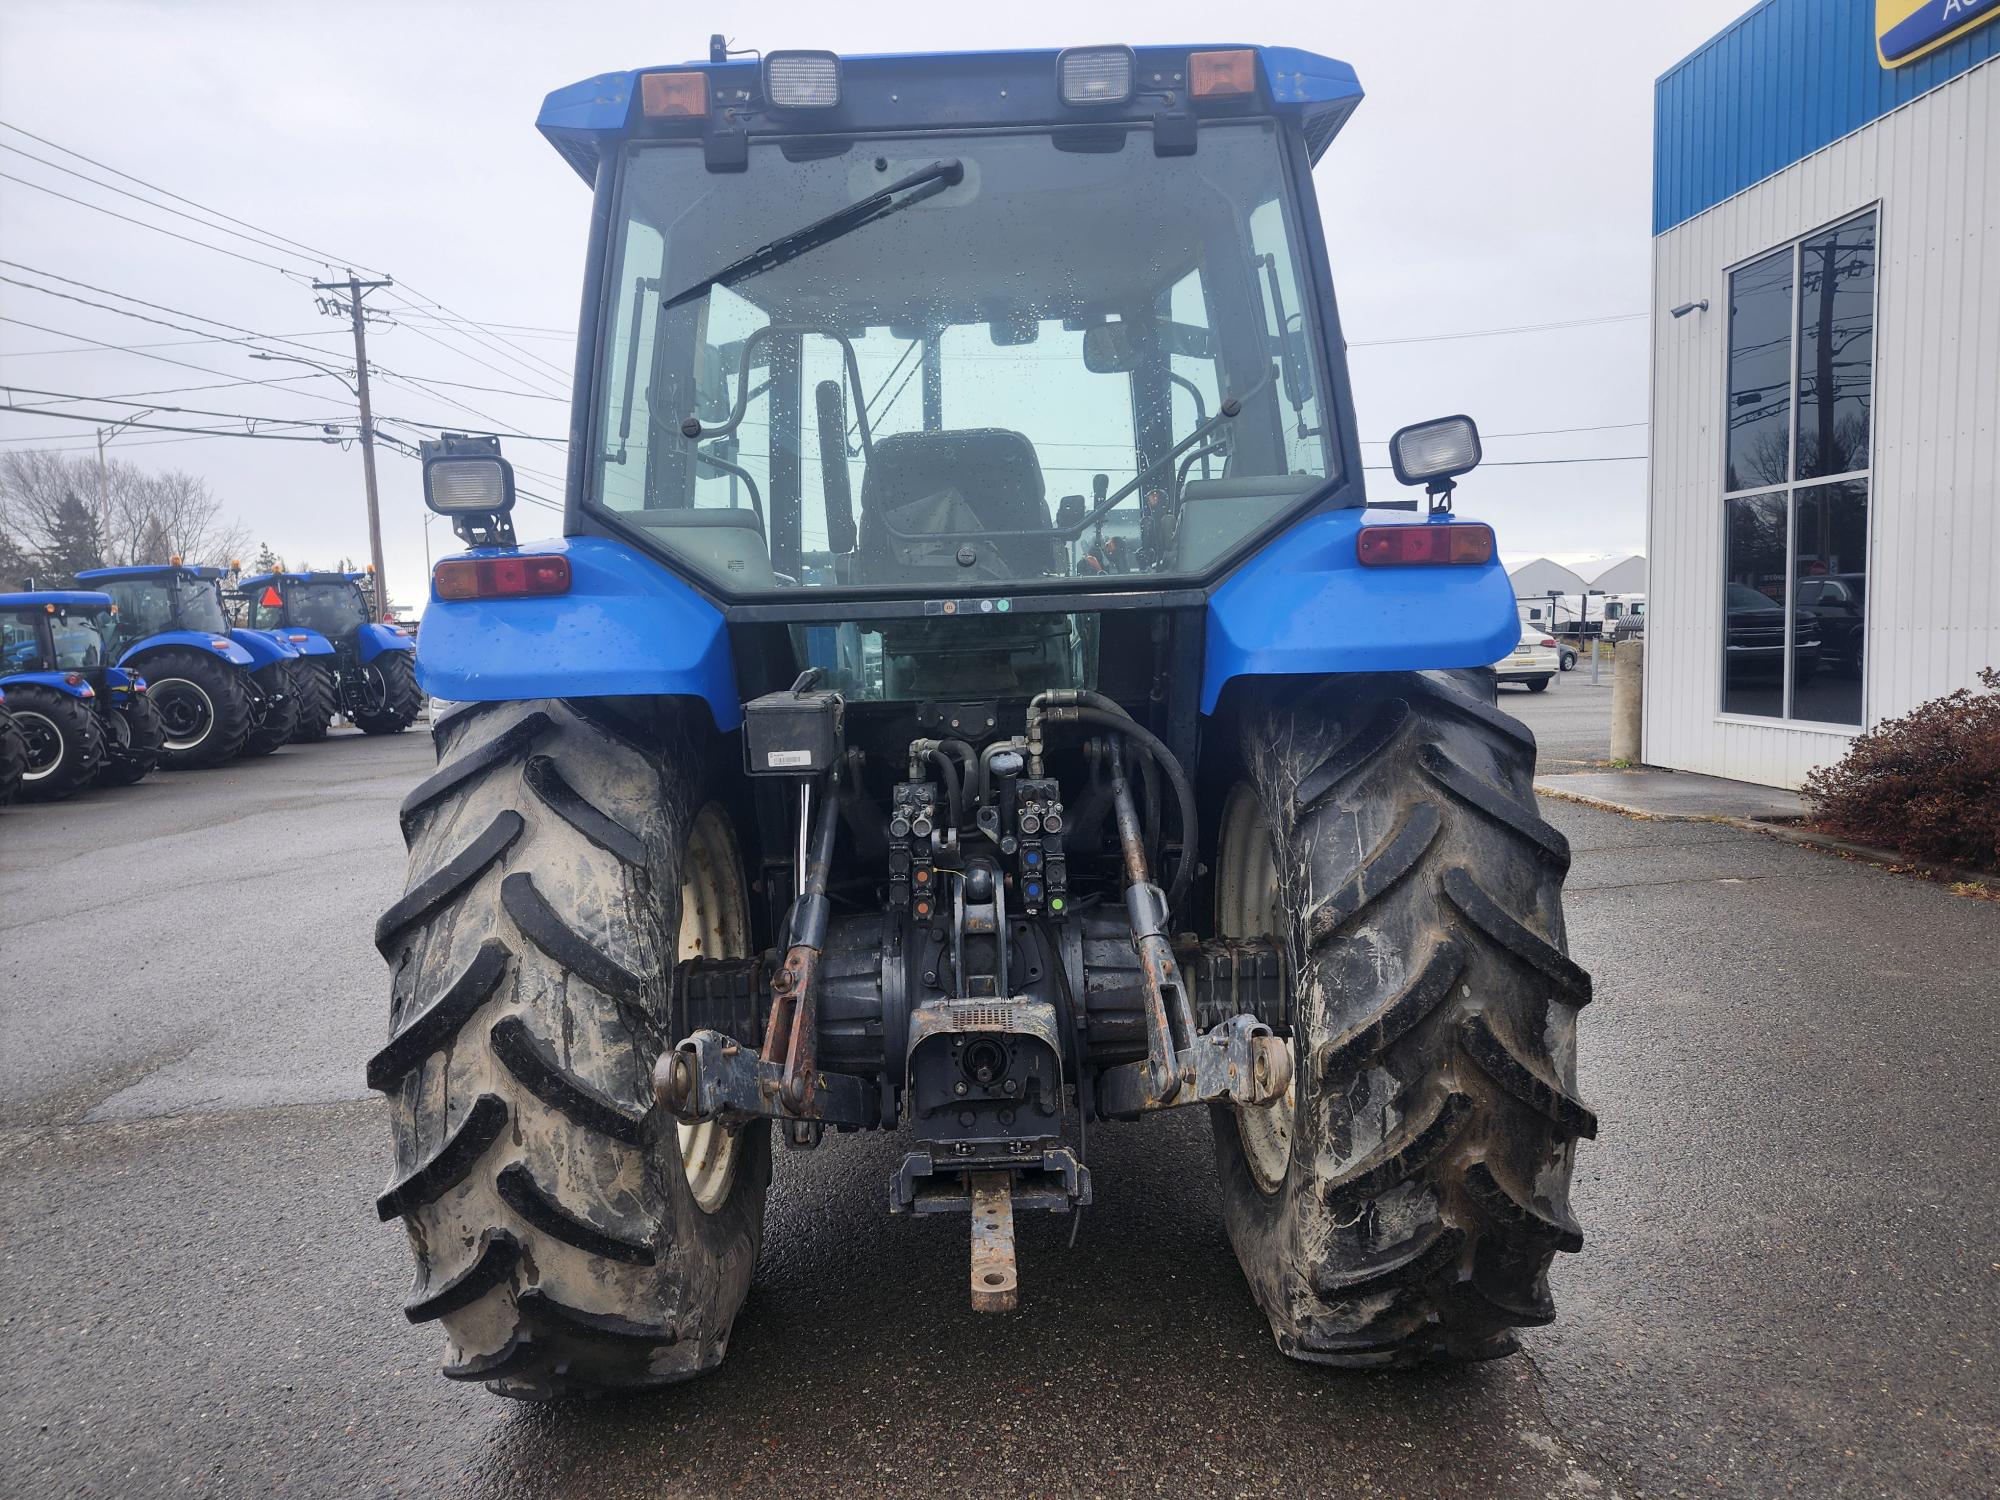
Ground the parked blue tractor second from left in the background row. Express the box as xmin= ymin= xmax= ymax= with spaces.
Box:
xmin=76 ymin=558 xmax=300 ymax=770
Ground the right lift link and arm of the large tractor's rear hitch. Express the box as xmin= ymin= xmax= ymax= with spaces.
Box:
xmin=1098 ymin=736 xmax=1292 ymax=1118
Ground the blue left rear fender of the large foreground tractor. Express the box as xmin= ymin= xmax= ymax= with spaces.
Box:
xmin=416 ymin=536 xmax=744 ymax=730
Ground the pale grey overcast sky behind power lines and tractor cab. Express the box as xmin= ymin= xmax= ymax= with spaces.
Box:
xmin=0 ymin=0 xmax=1748 ymax=604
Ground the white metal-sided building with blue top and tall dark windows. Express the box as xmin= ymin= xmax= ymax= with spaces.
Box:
xmin=1644 ymin=0 xmax=2000 ymax=786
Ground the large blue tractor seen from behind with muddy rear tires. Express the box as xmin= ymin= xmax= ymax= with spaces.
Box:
xmin=368 ymin=38 xmax=1596 ymax=1398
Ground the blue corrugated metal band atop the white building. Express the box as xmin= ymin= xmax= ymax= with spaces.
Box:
xmin=1652 ymin=0 xmax=2000 ymax=234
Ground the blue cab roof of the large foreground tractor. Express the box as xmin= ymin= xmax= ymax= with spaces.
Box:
xmin=536 ymin=42 xmax=1362 ymax=182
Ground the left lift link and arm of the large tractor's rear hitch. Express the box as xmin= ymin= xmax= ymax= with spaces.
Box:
xmin=652 ymin=796 xmax=878 ymax=1146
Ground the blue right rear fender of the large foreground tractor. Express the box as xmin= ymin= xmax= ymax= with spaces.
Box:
xmin=1202 ymin=510 xmax=1520 ymax=714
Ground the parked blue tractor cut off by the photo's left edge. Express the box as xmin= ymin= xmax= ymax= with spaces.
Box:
xmin=0 ymin=590 xmax=166 ymax=802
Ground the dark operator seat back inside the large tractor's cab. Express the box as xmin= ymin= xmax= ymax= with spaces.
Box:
xmin=856 ymin=428 xmax=1062 ymax=580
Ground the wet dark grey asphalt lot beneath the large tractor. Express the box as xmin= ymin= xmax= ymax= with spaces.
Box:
xmin=0 ymin=680 xmax=2000 ymax=1498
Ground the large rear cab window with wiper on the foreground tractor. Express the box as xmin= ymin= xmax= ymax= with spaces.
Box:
xmin=592 ymin=122 xmax=1336 ymax=592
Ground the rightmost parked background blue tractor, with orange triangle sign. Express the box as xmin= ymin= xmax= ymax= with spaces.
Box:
xmin=236 ymin=572 xmax=424 ymax=740
